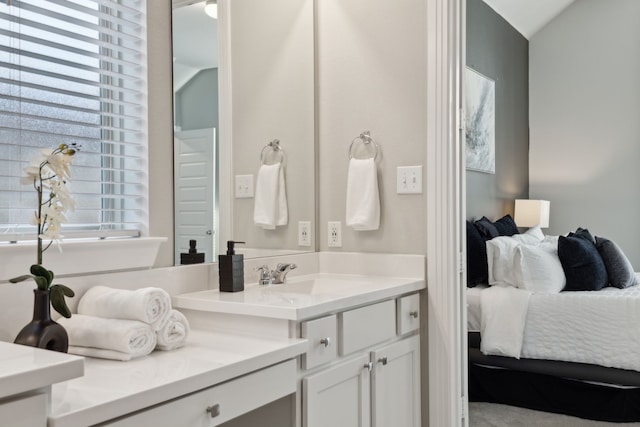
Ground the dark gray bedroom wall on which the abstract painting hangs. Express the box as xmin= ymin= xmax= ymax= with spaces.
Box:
xmin=466 ymin=0 xmax=529 ymax=219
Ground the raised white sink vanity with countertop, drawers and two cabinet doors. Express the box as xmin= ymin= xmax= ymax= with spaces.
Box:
xmin=174 ymin=254 xmax=425 ymax=427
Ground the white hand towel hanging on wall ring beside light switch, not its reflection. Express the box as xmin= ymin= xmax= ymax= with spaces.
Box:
xmin=347 ymin=158 xmax=380 ymax=231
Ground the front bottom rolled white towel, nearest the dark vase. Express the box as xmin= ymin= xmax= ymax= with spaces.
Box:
xmin=58 ymin=314 xmax=157 ymax=360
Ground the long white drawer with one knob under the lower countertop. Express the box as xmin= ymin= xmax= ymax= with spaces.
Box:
xmin=100 ymin=360 xmax=296 ymax=427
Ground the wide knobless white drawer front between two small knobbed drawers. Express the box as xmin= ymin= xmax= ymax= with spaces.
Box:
xmin=339 ymin=300 xmax=396 ymax=355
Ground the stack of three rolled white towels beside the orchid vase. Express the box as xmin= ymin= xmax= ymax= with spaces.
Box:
xmin=59 ymin=286 xmax=190 ymax=360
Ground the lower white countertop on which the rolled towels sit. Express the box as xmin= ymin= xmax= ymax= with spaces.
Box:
xmin=48 ymin=330 xmax=307 ymax=427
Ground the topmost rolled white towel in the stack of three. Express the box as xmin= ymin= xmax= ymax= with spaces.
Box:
xmin=78 ymin=286 xmax=171 ymax=331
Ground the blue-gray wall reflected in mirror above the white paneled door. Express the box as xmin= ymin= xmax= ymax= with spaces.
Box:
xmin=175 ymin=68 xmax=218 ymax=130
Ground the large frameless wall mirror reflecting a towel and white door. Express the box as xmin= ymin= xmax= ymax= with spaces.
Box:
xmin=172 ymin=0 xmax=316 ymax=264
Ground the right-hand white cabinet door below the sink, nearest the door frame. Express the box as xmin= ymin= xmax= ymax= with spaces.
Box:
xmin=371 ymin=335 xmax=420 ymax=427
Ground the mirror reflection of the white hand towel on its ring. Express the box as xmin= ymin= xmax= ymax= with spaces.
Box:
xmin=253 ymin=163 xmax=289 ymax=230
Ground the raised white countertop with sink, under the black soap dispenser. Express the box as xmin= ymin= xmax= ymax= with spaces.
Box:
xmin=173 ymin=273 xmax=425 ymax=321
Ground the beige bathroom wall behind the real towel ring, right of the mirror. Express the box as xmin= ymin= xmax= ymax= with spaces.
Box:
xmin=316 ymin=0 xmax=427 ymax=254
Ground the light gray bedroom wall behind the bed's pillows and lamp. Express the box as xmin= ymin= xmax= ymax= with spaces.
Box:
xmin=529 ymin=0 xmax=640 ymax=270
